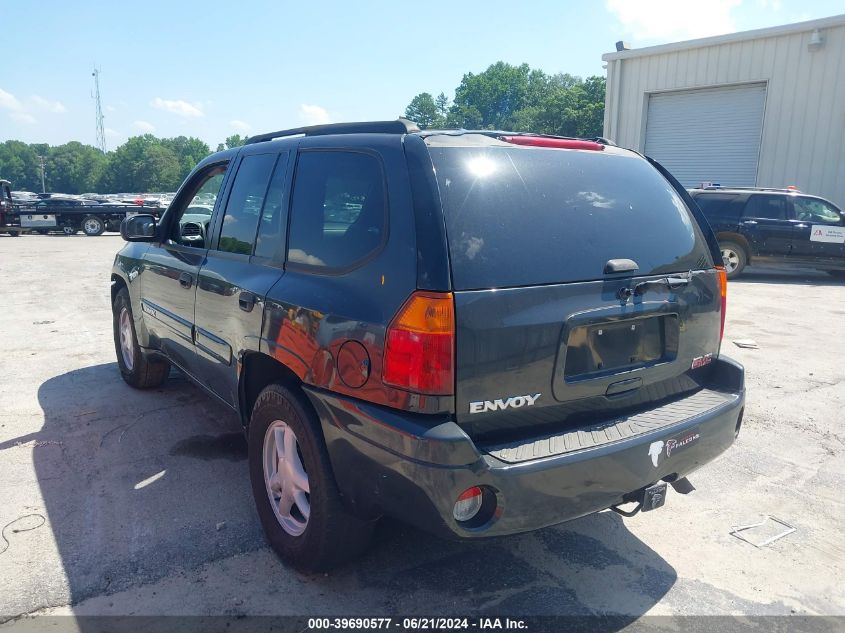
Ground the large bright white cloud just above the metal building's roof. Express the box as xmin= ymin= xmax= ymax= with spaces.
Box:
xmin=605 ymin=0 xmax=741 ymax=42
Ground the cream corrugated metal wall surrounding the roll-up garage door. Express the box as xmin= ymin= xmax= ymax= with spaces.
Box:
xmin=604 ymin=18 xmax=845 ymax=208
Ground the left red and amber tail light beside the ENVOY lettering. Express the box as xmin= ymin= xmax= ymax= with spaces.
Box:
xmin=383 ymin=292 xmax=455 ymax=395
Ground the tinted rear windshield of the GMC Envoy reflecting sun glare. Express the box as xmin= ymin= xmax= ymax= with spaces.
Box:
xmin=429 ymin=146 xmax=713 ymax=290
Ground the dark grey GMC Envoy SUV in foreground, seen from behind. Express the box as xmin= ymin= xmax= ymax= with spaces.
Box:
xmin=112 ymin=119 xmax=745 ymax=569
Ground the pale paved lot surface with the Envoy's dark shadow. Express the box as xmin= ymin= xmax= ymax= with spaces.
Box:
xmin=0 ymin=235 xmax=845 ymax=621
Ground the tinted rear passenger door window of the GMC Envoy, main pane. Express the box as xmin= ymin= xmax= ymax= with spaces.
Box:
xmin=217 ymin=154 xmax=278 ymax=255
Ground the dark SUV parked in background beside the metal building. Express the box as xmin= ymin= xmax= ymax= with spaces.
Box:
xmin=689 ymin=186 xmax=845 ymax=279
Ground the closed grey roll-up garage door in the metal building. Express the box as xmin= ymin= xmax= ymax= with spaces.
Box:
xmin=645 ymin=84 xmax=766 ymax=187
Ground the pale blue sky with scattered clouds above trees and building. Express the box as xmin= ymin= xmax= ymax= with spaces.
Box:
xmin=0 ymin=0 xmax=843 ymax=148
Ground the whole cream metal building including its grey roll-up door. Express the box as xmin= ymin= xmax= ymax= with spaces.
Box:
xmin=602 ymin=15 xmax=845 ymax=209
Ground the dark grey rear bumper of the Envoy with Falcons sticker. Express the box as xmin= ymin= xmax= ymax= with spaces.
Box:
xmin=307 ymin=357 xmax=745 ymax=538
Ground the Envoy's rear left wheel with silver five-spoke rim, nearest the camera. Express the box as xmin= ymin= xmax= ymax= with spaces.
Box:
xmin=248 ymin=384 xmax=374 ymax=572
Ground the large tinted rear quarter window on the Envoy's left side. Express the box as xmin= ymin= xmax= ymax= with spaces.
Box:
xmin=288 ymin=151 xmax=386 ymax=268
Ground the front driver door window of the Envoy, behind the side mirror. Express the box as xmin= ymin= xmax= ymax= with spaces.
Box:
xmin=166 ymin=163 xmax=228 ymax=248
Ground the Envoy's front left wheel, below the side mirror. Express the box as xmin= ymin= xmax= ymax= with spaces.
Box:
xmin=112 ymin=288 xmax=170 ymax=389
